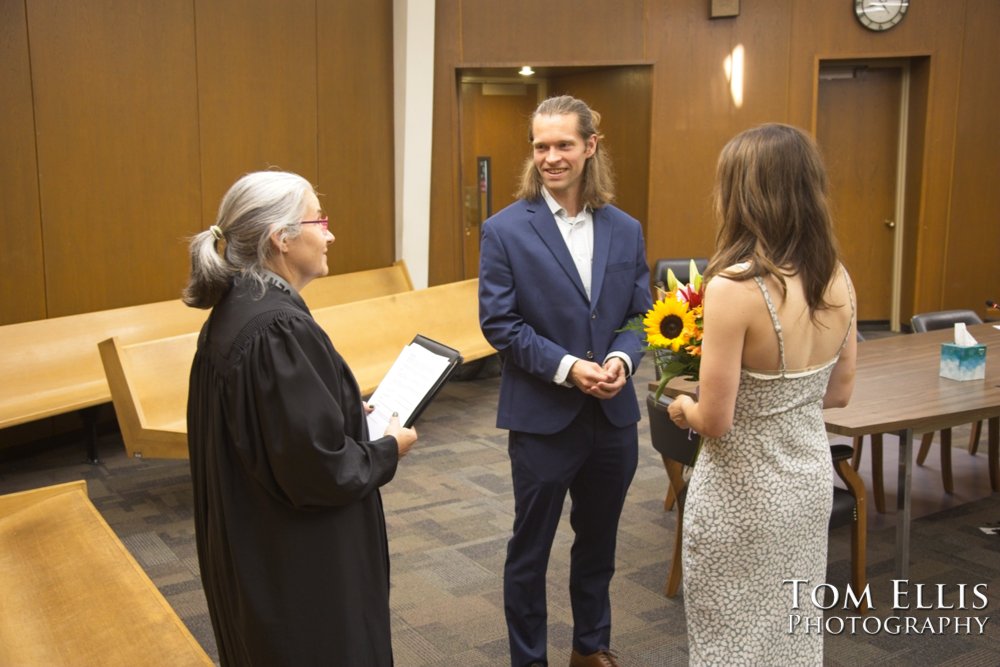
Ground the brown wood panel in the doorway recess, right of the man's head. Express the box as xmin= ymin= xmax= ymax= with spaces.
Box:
xmin=550 ymin=65 xmax=652 ymax=241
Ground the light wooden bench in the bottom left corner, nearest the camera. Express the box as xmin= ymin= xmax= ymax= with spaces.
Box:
xmin=0 ymin=480 xmax=214 ymax=667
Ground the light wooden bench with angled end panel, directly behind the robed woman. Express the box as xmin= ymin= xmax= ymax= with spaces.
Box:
xmin=99 ymin=278 xmax=495 ymax=458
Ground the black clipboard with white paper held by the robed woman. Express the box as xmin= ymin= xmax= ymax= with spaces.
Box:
xmin=368 ymin=334 xmax=462 ymax=438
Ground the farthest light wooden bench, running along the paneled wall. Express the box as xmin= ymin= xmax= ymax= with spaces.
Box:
xmin=0 ymin=261 xmax=413 ymax=460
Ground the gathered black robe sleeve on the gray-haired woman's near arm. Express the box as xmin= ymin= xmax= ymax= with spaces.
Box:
xmin=227 ymin=310 xmax=399 ymax=508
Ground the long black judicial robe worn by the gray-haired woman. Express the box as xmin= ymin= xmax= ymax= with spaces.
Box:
xmin=188 ymin=281 xmax=398 ymax=667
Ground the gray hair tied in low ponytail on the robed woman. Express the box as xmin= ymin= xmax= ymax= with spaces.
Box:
xmin=183 ymin=171 xmax=313 ymax=308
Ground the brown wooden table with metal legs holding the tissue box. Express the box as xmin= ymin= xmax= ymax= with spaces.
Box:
xmin=824 ymin=324 xmax=1000 ymax=579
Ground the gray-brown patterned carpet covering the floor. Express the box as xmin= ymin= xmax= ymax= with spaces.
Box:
xmin=0 ymin=364 xmax=1000 ymax=667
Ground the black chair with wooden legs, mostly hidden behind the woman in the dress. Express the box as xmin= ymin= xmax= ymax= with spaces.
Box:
xmin=646 ymin=393 xmax=868 ymax=612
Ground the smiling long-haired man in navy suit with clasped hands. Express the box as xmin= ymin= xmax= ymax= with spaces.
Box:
xmin=479 ymin=96 xmax=651 ymax=667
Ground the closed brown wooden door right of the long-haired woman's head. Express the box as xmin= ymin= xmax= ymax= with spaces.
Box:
xmin=816 ymin=66 xmax=903 ymax=328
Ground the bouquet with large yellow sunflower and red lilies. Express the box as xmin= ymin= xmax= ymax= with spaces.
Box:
xmin=628 ymin=260 xmax=705 ymax=399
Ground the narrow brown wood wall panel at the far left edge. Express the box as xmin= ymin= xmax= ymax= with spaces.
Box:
xmin=0 ymin=2 xmax=45 ymax=324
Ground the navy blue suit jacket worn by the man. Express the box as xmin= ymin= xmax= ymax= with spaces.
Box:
xmin=479 ymin=199 xmax=651 ymax=434
